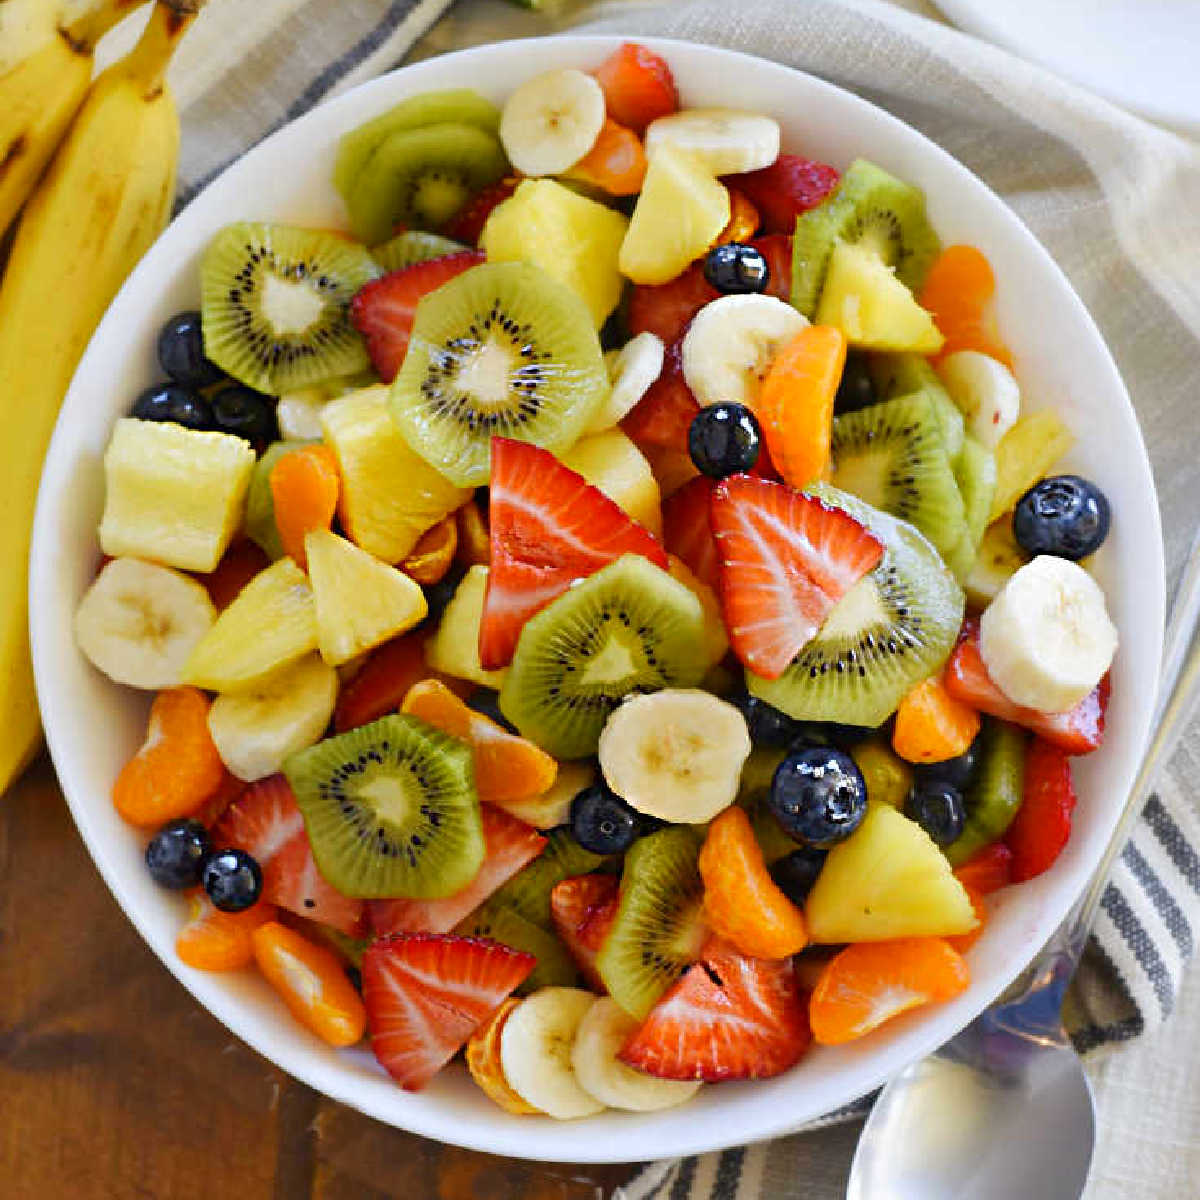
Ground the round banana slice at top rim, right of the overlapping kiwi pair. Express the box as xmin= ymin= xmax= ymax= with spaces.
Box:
xmin=500 ymin=67 xmax=605 ymax=175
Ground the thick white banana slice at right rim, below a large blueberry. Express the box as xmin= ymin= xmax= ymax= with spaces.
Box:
xmin=979 ymin=554 xmax=1117 ymax=713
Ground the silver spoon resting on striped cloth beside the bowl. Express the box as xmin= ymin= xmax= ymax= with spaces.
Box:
xmin=846 ymin=536 xmax=1200 ymax=1200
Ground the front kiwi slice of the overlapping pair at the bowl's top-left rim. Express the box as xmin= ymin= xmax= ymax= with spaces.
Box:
xmin=346 ymin=122 xmax=509 ymax=246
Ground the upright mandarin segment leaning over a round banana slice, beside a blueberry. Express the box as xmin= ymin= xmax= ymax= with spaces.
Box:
xmin=755 ymin=325 xmax=846 ymax=488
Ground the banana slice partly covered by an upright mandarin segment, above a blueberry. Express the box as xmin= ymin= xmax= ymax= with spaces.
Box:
xmin=683 ymin=295 xmax=809 ymax=408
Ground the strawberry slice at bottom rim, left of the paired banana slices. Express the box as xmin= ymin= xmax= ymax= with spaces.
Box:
xmin=362 ymin=934 xmax=538 ymax=1092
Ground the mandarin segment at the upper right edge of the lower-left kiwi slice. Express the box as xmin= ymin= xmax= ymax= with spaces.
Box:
xmin=401 ymin=679 xmax=558 ymax=804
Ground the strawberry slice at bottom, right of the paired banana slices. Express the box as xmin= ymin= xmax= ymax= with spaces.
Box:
xmin=618 ymin=938 xmax=812 ymax=1082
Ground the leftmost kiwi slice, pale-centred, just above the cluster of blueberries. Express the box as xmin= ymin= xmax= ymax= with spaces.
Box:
xmin=200 ymin=222 xmax=379 ymax=396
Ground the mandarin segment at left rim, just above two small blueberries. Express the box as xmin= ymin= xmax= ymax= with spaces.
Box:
xmin=113 ymin=688 xmax=226 ymax=826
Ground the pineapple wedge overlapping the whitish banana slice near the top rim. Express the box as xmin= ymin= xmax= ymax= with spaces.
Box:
xmin=619 ymin=145 xmax=730 ymax=283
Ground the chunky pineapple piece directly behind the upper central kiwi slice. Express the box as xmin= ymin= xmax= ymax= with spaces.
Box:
xmin=479 ymin=179 xmax=629 ymax=329
